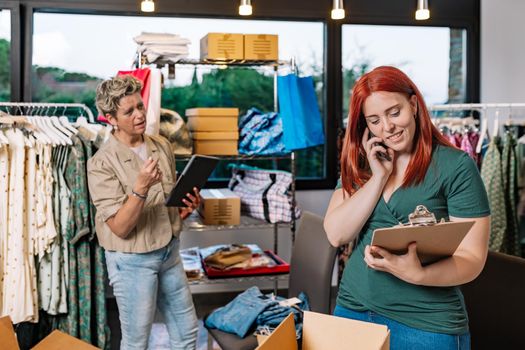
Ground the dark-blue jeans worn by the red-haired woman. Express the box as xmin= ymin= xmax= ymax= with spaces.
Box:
xmin=334 ymin=305 xmax=470 ymax=350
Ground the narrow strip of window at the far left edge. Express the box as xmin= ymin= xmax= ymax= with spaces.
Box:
xmin=0 ymin=9 xmax=11 ymax=102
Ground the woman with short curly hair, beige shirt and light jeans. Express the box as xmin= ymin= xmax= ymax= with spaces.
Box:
xmin=88 ymin=76 xmax=200 ymax=349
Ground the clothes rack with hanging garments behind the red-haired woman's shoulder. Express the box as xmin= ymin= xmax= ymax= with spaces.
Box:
xmin=429 ymin=103 xmax=525 ymax=256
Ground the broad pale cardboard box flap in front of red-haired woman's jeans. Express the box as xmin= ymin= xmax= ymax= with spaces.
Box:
xmin=303 ymin=311 xmax=390 ymax=350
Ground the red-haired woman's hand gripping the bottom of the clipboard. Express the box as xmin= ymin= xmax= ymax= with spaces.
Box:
xmin=364 ymin=243 xmax=425 ymax=284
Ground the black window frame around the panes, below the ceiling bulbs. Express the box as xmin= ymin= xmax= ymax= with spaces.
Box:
xmin=0 ymin=0 xmax=480 ymax=190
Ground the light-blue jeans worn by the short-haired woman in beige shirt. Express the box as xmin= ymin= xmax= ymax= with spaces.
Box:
xmin=106 ymin=238 xmax=198 ymax=350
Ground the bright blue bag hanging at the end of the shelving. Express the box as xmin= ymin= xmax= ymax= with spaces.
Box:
xmin=277 ymin=74 xmax=324 ymax=151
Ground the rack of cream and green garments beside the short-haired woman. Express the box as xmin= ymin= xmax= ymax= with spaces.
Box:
xmin=0 ymin=102 xmax=110 ymax=349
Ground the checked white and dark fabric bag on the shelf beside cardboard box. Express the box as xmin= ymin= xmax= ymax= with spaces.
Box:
xmin=228 ymin=165 xmax=301 ymax=223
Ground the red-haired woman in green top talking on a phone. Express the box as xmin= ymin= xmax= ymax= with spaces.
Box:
xmin=324 ymin=66 xmax=490 ymax=350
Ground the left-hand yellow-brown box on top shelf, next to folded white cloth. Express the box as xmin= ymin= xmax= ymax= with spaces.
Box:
xmin=201 ymin=33 xmax=244 ymax=61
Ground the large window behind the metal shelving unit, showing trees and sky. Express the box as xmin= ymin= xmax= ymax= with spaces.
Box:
xmin=32 ymin=13 xmax=326 ymax=179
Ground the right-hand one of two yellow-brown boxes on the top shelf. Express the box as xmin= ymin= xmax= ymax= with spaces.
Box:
xmin=244 ymin=34 xmax=279 ymax=61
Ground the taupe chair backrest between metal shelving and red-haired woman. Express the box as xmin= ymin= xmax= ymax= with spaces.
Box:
xmin=288 ymin=211 xmax=337 ymax=313
